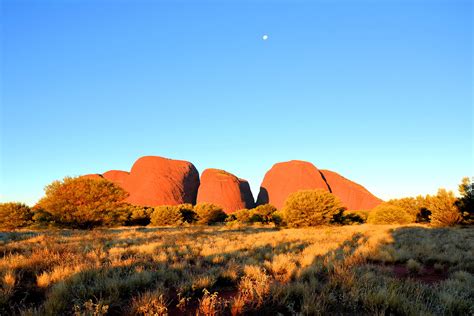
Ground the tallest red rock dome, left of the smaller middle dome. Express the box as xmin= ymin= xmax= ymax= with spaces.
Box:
xmin=124 ymin=156 xmax=199 ymax=206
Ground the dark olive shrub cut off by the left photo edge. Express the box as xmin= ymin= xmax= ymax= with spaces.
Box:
xmin=0 ymin=202 xmax=33 ymax=229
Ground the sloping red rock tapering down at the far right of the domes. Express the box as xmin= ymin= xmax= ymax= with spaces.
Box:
xmin=321 ymin=170 xmax=382 ymax=210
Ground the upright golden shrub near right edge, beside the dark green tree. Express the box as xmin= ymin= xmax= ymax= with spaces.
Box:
xmin=427 ymin=189 xmax=462 ymax=226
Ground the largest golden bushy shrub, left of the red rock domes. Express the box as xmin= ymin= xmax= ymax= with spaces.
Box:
xmin=36 ymin=177 xmax=127 ymax=228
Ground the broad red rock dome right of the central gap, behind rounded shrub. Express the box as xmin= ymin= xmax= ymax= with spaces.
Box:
xmin=257 ymin=160 xmax=329 ymax=209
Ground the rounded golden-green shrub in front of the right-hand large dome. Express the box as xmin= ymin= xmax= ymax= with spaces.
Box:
xmin=283 ymin=190 xmax=342 ymax=227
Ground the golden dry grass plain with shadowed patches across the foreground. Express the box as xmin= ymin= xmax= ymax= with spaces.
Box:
xmin=0 ymin=225 xmax=474 ymax=315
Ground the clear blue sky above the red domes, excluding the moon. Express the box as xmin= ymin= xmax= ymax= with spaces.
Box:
xmin=0 ymin=0 xmax=474 ymax=204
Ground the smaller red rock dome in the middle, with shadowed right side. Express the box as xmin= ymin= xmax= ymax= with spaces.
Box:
xmin=197 ymin=169 xmax=254 ymax=213
